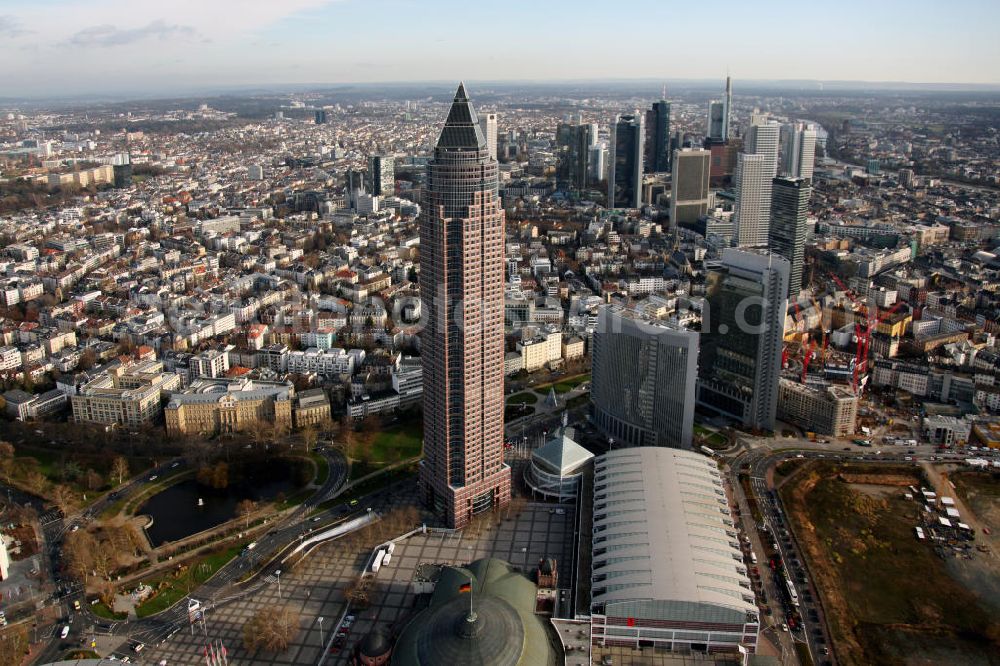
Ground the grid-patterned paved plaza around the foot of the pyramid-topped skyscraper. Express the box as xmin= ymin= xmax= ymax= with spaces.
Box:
xmin=128 ymin=503 xmax=574 ymax=665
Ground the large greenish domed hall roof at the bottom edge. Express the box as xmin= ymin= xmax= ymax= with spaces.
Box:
xmin=392 ymin=559 xmax=561 ymax=666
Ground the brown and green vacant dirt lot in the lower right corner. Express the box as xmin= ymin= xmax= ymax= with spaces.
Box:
xmin=781 ymin=463 xmax=1000 ymax=666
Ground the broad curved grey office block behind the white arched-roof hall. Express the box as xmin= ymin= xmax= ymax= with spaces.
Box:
xmin=591 ymin=306 xmax=698 ymax=449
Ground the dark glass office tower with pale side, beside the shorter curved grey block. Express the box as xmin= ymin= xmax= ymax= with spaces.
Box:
xmin=698 ymin=248 xmax=789 ymax=430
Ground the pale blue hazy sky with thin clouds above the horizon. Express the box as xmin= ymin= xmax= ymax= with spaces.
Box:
xmin=0 ymin=0 xmax=1000 ymax=97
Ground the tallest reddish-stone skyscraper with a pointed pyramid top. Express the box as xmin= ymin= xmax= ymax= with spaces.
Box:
xmin=420 ymin=84 xmax=510 ymax=527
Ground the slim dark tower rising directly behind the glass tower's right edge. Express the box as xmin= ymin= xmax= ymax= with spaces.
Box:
xmin=768 ymin=176 xmax=812 ymax=299
